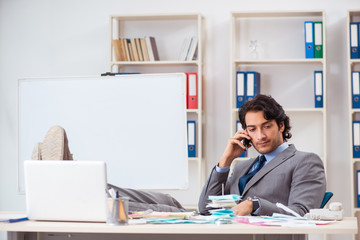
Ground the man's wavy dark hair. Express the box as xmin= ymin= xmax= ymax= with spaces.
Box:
xmin=239 ymin=94 xmax=292 ymax=141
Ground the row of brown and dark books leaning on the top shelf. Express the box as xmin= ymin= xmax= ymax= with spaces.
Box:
xmin=112 ymin=37 xmax=160 ymax=62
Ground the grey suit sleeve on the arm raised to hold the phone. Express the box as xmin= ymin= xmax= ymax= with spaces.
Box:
xmin=198 ymin=167 xmax=229 ymax=215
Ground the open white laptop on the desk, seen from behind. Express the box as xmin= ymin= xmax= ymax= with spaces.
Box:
xmin=24 ymin=160 xmax=107 ymax=222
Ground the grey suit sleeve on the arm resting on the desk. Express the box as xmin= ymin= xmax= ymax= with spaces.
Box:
xmin=259 ymin=152 xmax=326 ymax=216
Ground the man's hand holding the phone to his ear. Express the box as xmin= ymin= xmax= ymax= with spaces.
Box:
xmin=219 ymin=130 xmax=251 ymax=168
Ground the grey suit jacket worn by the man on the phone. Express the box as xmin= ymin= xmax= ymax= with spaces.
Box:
xmin=199 ymin=145 xmax=326 ymax=216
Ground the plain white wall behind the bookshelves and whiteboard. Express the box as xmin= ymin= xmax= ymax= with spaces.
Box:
xmin=0 ymin=0 xmax=360 ymax=238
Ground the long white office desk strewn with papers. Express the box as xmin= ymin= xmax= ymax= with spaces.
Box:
xmin=0 ymin=217 xmax=358 ymax=240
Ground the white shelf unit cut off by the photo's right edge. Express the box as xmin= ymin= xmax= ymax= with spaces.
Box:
xmin=346 ymin=9 xmax=360 ymax=239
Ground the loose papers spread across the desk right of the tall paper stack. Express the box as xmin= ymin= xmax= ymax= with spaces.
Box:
xmin=234 ymin=214 xmax=336 ymax=227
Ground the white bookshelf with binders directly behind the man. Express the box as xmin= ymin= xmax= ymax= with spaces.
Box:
xmin=229 ymin=11 xmax=327 ymax=237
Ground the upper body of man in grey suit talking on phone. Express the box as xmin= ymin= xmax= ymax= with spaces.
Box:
xmin=199 ymin=95 xmax=326 ymax=216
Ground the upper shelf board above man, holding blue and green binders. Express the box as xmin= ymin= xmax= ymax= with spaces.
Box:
xmin=234 ymin=58 xmax=323 ymax=64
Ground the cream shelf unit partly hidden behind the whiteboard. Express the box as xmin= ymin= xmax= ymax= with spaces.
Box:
xmin=110 ymin=14 xmax=205 ymax=208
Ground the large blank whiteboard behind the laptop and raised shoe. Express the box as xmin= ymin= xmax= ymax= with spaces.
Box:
xmin=18 ymin=73 xmax=188 ymax=192
